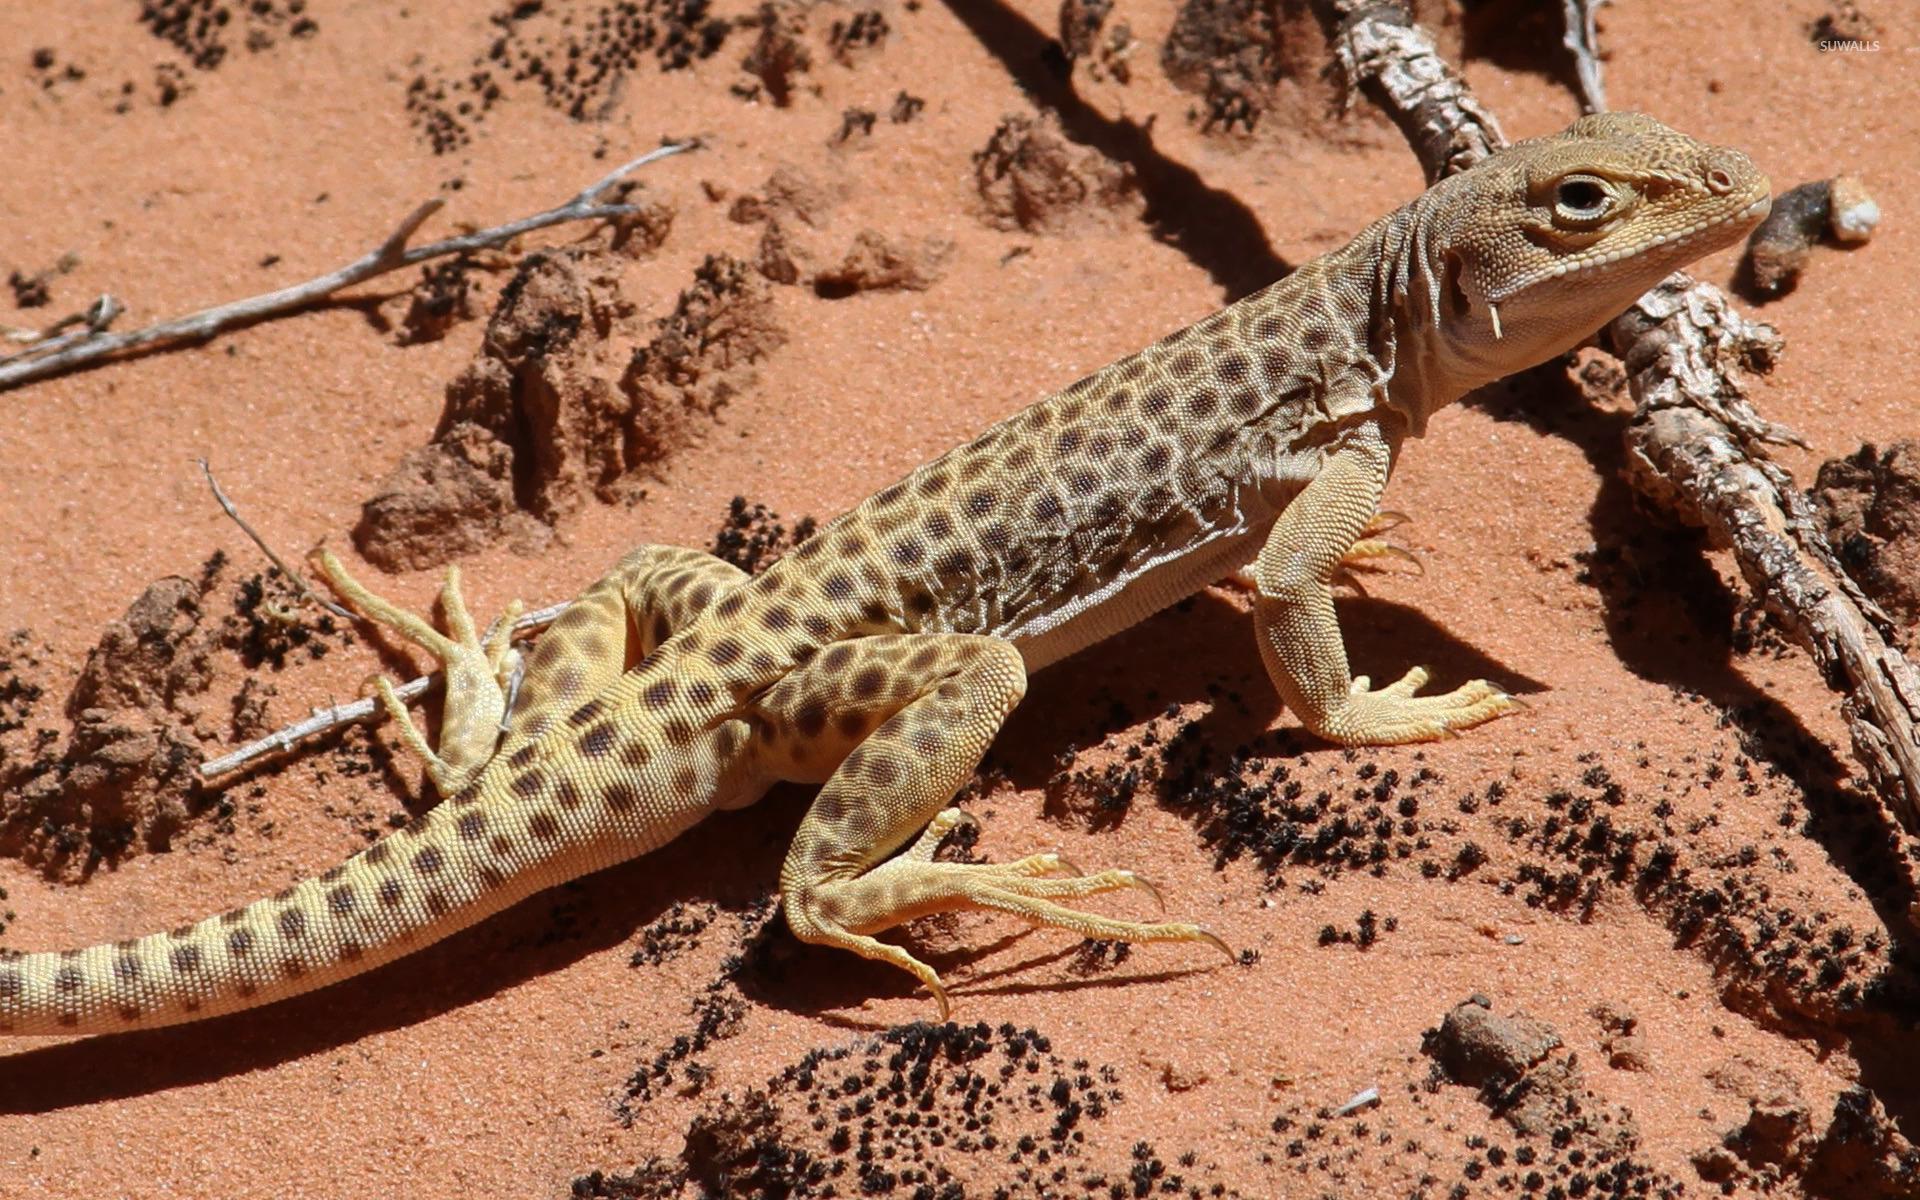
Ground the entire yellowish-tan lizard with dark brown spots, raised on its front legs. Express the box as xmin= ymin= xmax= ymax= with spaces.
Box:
xmin=0 ymin=115 xmax=1768 ymax=1033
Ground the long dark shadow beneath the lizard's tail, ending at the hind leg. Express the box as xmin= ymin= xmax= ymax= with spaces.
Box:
xmin=0 ymin=797 xmax=799 ymax=1116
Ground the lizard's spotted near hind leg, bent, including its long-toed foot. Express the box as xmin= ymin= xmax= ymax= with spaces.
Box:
xmin=762 ymin=634 xmax=1225 ymax=1020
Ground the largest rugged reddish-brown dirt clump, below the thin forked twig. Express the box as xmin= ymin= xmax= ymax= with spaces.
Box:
xmin=353 ymin=252 xmax=781 ymax=570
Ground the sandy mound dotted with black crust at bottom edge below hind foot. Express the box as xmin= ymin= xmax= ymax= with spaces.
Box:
xmin=595 ymin=1021 xmax=1238 ymax=1200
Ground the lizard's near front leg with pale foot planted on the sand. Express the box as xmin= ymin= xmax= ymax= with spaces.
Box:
xmin=1254 ymin=424 xmax=1517 ymax=745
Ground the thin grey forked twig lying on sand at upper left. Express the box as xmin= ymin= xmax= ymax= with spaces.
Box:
xmin=0 ymin=140 xmax=699 ymax=392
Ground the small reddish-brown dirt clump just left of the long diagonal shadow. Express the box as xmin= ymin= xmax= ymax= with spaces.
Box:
xmin=973 ymin=113 xmax=1139 ymax=232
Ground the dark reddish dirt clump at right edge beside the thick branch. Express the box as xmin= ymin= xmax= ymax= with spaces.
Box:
xmin=1812 ymin=440 xmax=1920 ymax=653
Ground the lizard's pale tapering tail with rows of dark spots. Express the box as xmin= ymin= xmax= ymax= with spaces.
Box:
xmin=0 ymin=789 xmax=603 ymax=1035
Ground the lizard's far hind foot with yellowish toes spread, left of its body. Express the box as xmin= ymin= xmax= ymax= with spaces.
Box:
xmin=315 ymin=549 xmax=520 ymax=795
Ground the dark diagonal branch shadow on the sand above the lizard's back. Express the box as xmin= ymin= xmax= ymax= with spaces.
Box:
xmin=947 ymin=0 xmax=1292 ymax=301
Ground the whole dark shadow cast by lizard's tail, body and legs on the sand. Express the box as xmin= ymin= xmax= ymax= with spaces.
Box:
xmin=0 ymin=591 xmax=1540 ymax=1114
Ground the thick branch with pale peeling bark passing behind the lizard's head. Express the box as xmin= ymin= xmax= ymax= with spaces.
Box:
xmin=1321 ymin=0 xmax=1920 ymax=860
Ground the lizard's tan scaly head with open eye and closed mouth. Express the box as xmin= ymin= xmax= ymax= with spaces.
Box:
xmin=1402 ymin=113 xmax=1770 ymax=407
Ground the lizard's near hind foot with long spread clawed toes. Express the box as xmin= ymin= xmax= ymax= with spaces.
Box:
xmin=785 ymin=808 xmax=1233 ymax=1021
